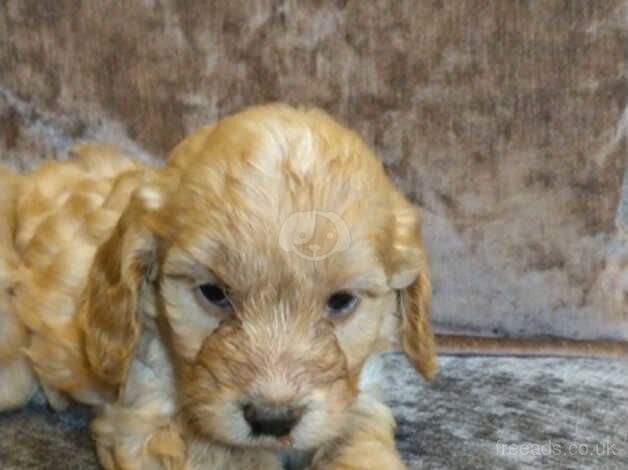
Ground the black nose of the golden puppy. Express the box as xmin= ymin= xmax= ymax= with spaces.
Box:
xmin=242 ymin=403 xmax=302 ymax=437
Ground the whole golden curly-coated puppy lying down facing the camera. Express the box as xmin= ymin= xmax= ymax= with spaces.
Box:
xmin=0 ymin=105 xmax=434 ymax=470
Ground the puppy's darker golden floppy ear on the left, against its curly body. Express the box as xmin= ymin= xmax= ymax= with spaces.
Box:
xmin=78 ymin=193 xmax=155 ymax=386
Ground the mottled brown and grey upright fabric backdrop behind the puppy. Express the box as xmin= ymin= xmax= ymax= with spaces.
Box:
xmin=0 ymin=0 xmax=628 ymax=339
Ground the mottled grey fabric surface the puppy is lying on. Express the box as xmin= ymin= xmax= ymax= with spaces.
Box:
xmin=0 ymin=355 xmax=628 ymax=470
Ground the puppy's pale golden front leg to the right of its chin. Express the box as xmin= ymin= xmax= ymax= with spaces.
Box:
xmin=310 ymin=397 xmax=406 ymax=470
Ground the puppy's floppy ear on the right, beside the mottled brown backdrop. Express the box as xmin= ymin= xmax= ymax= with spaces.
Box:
xmin=391 ymin=194 xmax=436 ymax=379
